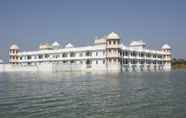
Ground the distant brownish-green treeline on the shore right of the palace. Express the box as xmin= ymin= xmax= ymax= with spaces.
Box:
xmin=172 ymin=58 xmax=186 ymax=68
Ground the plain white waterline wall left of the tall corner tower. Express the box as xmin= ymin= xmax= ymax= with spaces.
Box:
xmin=0 ymin=63 xmax=106 ymax=72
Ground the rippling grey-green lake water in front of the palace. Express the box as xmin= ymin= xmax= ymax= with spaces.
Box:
xmin=0 ymin=70 xmax=186 ymax=118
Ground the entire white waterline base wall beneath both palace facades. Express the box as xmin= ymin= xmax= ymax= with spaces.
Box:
xmin=0 ymin=63 xmax=171 ymax=72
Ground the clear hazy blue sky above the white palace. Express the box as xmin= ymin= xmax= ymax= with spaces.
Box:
xmin=0 ymin=0 xmax=186 ymax=61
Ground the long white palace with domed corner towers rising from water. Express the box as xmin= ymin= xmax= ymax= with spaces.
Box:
xmin=3 ymin=32 xmax=171 ymax=71
